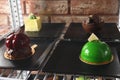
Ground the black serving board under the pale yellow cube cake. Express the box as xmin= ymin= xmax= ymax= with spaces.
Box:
xmin=26 ymin=23 xmax=65 ymax=39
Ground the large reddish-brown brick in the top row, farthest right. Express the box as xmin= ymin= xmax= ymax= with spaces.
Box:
xmin=71 ymin=0 xmax=118 ymax=14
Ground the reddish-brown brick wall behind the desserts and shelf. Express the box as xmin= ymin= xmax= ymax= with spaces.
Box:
xmin=0 ymin=0 xmax=118 ymax=26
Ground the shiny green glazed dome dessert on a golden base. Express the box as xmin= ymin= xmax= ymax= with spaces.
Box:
xmin=79 ymin=33 xmax=113 ymax=65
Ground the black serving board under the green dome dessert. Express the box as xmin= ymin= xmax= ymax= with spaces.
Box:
xmin=43 ymin=41 xmax=120 ymax=77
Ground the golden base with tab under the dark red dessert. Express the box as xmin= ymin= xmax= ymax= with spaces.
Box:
xmin=4 ymin=45 xmax=37 ymax=60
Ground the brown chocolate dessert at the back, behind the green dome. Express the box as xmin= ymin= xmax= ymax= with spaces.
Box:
xmin=82 ymin=14 xmax=104 ymax=33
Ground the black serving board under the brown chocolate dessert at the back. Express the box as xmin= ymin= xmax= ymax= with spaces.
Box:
xmin=64 ymin=23 xmax=120 ymax=41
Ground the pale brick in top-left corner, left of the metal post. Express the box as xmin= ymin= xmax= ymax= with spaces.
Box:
xmin=0 ymin=0 xmax=10 ymax=13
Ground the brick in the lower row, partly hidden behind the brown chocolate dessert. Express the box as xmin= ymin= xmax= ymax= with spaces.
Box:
xmin=51 ymin=15 xmax=118 ymax=23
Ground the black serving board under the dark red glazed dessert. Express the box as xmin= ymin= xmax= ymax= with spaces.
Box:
xmin=0 ymin=38 xmax=54 ymax=70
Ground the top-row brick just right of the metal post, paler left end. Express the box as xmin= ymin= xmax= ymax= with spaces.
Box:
xmin=26 ymin=0 xmax=68 ymax=14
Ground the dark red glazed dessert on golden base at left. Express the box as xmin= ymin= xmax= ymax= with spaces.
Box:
xmin=4 ymin=28 xmax=35 ymax=60
